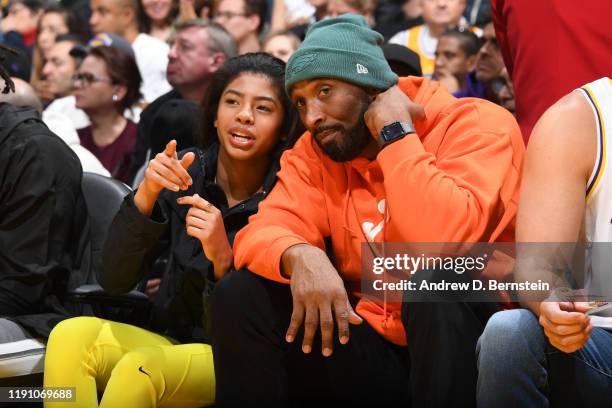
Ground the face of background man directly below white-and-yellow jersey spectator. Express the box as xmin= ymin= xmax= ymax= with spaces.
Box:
xmin=434 ymin=36 xmax=476 ymax=81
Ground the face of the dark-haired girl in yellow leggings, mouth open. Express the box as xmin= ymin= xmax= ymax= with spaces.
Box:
xmin=215 ymin=73 xmax=284 ymax=160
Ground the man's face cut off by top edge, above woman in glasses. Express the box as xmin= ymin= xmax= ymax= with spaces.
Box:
xmin=89 ymin=0 xmax=133 ymax=35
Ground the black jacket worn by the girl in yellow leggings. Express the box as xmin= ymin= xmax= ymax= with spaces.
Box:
xmin=98 ymin=145 xmax=279 ymax=343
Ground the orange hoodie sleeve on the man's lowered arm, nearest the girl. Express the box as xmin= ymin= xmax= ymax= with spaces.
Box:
xmin=234 ymin=136 xmax=329 ymax=283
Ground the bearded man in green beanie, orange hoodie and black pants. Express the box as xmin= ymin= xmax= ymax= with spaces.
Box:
xmin=212 ymin=14 xmax=524 ymax=407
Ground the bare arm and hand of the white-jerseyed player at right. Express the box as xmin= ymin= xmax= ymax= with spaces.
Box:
xmin=515 ymin=92 xmax=597 ymax=352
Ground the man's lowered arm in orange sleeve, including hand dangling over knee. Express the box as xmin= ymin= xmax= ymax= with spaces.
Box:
xmin=234 ymin=137 xmax=361 ymax=356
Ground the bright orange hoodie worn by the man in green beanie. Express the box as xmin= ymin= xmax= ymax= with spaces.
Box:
xmin=234 ymin=77 xmax=525 ymax=345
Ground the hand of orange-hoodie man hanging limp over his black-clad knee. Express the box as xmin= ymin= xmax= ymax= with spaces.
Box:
xmin=282 ymin=245 xmax=362 ymax=357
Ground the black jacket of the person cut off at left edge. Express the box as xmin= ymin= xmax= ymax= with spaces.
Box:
xmin=0 ymin=103 xmax=89 ymax=337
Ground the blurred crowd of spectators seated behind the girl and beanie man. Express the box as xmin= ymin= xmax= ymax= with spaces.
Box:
xmin=0 ymin=0 xmax=515 ymax=187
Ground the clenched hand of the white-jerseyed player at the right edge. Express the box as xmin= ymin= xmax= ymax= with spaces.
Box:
xmin=540 ymin=301 xmax=593 ymax=353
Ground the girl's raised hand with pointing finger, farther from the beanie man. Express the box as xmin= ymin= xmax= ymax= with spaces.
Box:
xmin=134 ymin=140 xmax=195 ymax=217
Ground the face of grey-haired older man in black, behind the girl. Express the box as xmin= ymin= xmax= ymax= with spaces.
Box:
xmin=166 ymin=27 xmax=216 ymax=88
